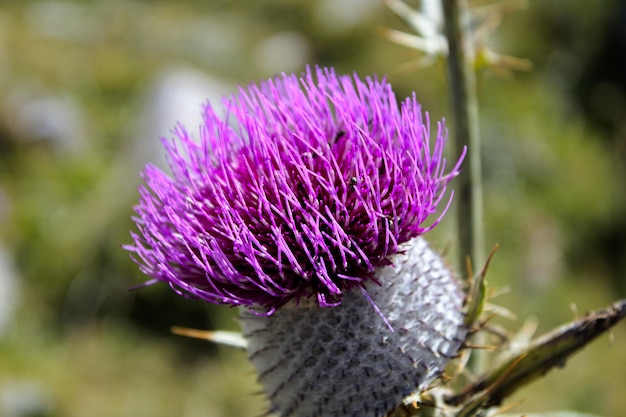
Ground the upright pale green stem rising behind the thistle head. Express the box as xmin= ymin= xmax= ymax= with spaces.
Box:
xmin=441 ymin=0 xmax=485 ymax=371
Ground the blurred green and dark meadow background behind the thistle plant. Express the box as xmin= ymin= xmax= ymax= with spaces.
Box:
xmin=0 ymin=0 xmax=626 ymax=417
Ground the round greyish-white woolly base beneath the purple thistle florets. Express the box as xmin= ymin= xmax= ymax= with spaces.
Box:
xmin=241 ymin=238 xmax=467 ymax=417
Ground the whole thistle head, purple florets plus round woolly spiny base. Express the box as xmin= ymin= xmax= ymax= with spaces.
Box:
xmin=126 ymin=68 xmax=466 ymax=417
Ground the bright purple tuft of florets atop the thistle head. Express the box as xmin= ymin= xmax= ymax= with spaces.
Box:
xmin=125 ymin=68 xmax=462 ymax=315
